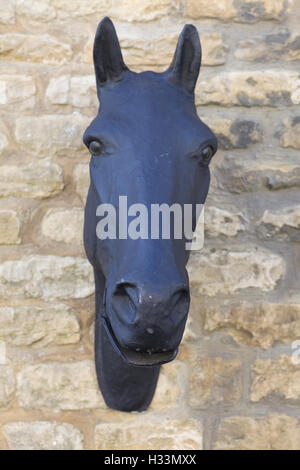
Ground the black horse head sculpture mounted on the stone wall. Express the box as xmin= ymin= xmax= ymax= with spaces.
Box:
xmin=83 ymin=18 xmax=217 ymax=411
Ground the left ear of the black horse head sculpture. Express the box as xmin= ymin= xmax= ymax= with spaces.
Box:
xmin=93 ymin=17 xmax=128 ymax=91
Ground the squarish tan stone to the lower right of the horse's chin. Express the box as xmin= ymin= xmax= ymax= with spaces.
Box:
xmin=189 ymin=357 xmax=242 ymax=407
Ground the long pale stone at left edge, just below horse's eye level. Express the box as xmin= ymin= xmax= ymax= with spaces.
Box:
xmin=0 ymin=162 xmax=64 ymax=199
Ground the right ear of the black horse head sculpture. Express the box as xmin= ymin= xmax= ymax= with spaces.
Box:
xmin=166 ymin=24 xmax=201 ymax=94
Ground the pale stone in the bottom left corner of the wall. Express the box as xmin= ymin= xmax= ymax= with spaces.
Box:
xmin=2 ymin=421 xmax=83 ymax=450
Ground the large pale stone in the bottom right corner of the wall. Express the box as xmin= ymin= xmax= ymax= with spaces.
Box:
xmin=214 ymin=413 xmax=300 ymax=450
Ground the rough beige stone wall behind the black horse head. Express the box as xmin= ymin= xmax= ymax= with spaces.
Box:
xmin=0 ymin=0 xmax=300 ymax=449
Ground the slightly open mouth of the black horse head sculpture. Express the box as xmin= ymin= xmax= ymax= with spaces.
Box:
xmin=101 ymin=315 xmax=178 ymax=367
